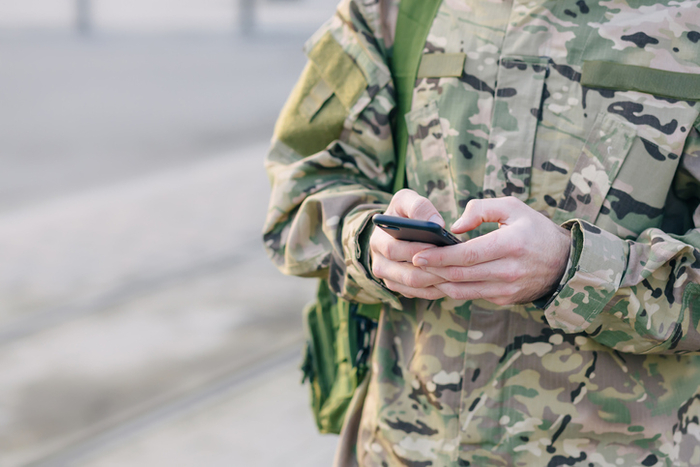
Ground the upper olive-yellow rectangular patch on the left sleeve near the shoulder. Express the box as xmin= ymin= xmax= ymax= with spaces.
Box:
xmin=309 ymin=32 xmax=367 ymax=109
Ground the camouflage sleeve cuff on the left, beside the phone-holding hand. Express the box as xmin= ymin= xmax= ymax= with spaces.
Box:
xmin=342 ymin=205 xmax=403 ymax=310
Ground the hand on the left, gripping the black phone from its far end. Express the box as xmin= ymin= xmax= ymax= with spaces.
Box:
xmin=369 ymin=189 xmax=446 ymax=300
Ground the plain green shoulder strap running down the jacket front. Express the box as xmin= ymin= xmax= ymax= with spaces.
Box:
xmin=390 ymin=0 xmax=442 ymax=193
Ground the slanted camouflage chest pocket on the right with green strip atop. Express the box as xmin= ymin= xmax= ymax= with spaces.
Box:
xmin=553 ymin=62 xmax=700 ymax=239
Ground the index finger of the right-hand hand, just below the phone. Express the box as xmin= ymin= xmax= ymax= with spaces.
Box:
xmin=412 ymin=230 xmax=510 ymax=268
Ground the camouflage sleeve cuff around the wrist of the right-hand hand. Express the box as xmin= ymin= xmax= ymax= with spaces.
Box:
xmin=544 ymin=219 xmax=629 ymax=333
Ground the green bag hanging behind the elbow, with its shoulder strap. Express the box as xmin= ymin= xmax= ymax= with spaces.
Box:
xmin=301 ymin=0 xmax=442 ymax=434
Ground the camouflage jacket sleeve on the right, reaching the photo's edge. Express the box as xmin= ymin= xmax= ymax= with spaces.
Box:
xmin=545 ymin=122 xmax=700 ymax=354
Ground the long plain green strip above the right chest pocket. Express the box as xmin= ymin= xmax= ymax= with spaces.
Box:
xmin=581 ymin=61 xmax=700 ymax=101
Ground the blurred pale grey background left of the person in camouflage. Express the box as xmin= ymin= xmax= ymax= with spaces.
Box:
xmin=0 ymin=0 xmax=336 ymax=467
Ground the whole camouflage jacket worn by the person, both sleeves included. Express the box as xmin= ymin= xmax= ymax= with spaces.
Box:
xmin=264 ymin=0 xmax=700 ymax=466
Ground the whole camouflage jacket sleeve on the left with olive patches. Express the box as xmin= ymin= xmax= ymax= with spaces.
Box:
xmin=263 ymin=0 xmax=400 ymax=306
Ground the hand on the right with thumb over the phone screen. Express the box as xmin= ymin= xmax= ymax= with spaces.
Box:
xmin=413 ymin=197 xmax=571 ymax=305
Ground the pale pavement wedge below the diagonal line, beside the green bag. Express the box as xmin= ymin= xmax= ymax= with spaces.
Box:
xmin=77 ymin=365 xmax=337 ymax=467
